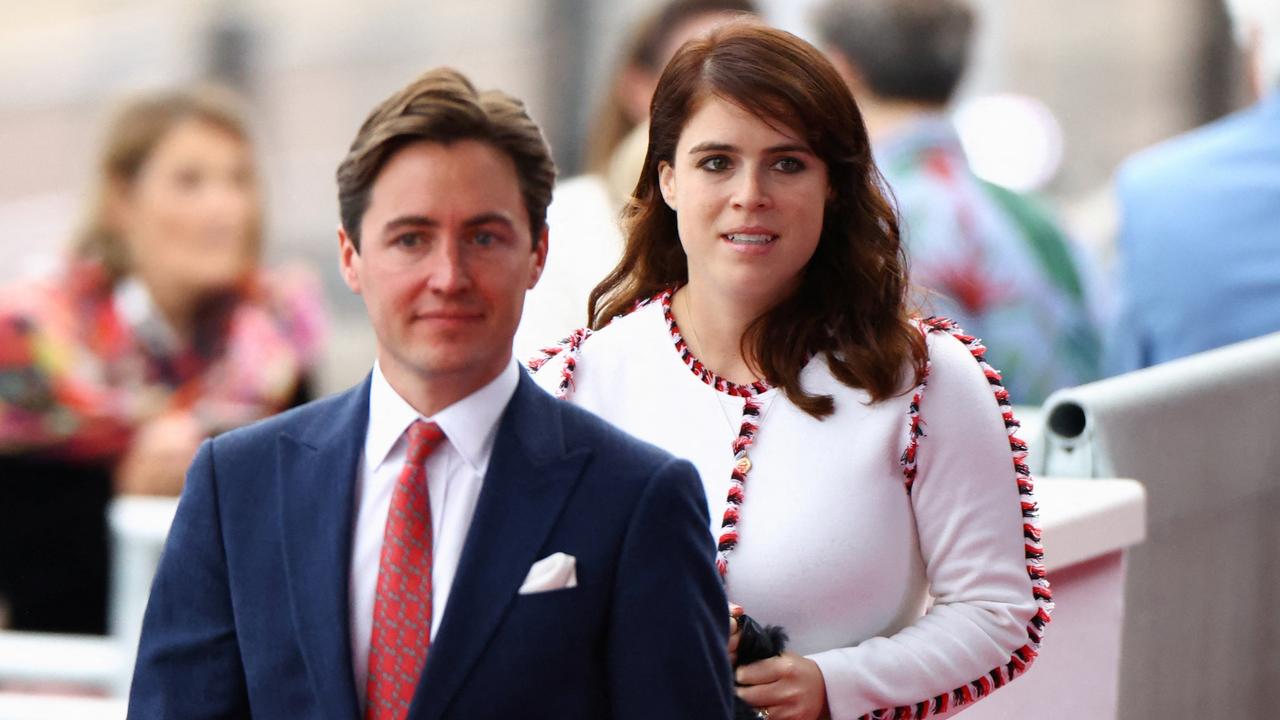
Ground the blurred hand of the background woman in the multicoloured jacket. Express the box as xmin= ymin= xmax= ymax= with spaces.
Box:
xmin=115 ymin=413 xmax=205 ymax=495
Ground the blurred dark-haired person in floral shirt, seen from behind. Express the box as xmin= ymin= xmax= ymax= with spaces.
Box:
xmin=815 ymin=0 xmax=1101 ymax=405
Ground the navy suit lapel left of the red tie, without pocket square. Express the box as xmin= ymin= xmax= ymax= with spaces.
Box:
xmin=276 ymin=378 xmax=369 ymax=720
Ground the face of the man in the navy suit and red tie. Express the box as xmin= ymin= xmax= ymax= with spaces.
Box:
xmin=338 ymin=140 xmax=547 ymax=392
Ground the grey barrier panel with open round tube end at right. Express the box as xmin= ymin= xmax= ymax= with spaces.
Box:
xmin=1034 ymin=333 xmax=1280 ymax=720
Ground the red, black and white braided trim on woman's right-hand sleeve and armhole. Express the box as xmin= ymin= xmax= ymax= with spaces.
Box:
xmin=875 ymin=318 xmax=1053 ymax=720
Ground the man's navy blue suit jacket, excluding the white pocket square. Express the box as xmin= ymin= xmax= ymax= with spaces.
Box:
xmin=129 ymin=374 xmax=733 ymax=720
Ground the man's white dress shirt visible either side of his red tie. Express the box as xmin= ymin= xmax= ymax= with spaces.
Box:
xmin=349 ymin=360 xmax=521 ymax=711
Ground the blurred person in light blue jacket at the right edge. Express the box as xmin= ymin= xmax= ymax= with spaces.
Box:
xmin=1106 ymin=0 xmax=1280 ymax=374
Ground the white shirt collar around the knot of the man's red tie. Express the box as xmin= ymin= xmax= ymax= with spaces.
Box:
xmin=365 ymin=359 xmax=520 ymax=474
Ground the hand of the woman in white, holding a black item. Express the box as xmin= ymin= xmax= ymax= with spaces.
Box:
xmin=730 ymin=650 xmax=831 ymax=720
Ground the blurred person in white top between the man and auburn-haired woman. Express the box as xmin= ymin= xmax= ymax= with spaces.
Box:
xmin=516 ymin=0 xmax=756 ymax=359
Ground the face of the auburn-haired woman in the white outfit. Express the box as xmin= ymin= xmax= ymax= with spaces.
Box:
xmin=658 ymin=96 xmax=829 ymax=305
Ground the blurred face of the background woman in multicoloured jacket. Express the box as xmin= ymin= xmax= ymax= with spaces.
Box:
xmin=116 ymin=119 xmax=259 ymax=293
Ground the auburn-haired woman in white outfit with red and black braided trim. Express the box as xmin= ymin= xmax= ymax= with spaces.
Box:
xmin=531 ymin=23 xmax=1051 ymax=720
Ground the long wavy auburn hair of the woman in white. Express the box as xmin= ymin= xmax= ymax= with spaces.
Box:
xmin=588 ymin=22 xmax=927 ymax=418
